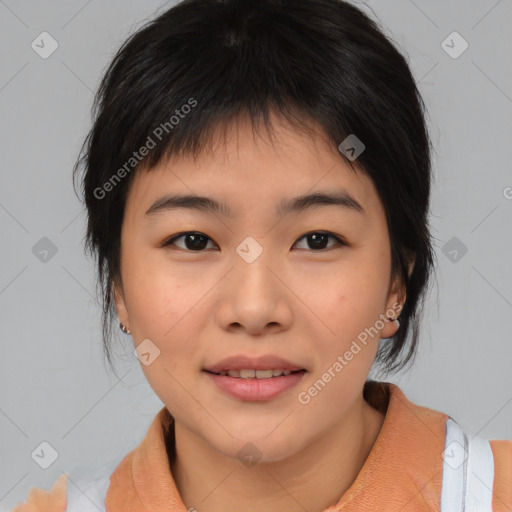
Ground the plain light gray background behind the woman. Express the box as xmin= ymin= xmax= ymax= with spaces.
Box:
xmin=0 ymin=0 xmax=512 ymax=510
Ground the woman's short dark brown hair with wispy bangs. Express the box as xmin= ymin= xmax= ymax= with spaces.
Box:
xmin=73 ymin=0 xmax=435 ymax=378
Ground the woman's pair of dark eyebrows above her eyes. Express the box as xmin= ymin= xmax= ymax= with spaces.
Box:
xmin=145 ymin=191 xmax=366 ymax=218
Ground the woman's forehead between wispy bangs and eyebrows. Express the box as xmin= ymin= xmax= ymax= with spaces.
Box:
xmin=126 ymin=113 xmax=378 ymax=220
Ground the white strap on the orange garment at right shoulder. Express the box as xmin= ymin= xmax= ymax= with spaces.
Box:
xmin=441 ymin=418 xmax=494 ymax=512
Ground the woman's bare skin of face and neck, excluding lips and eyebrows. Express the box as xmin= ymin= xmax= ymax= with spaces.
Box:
xmin=114 ymin=116 xmax=412 ymax=512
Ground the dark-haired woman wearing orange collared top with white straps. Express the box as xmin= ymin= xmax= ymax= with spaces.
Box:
xmin=15 ymin=0 xmax=512 ymax=512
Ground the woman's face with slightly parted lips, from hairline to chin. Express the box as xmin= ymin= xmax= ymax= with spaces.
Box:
xmin=116 ymin=115 xmax=403 ymax=462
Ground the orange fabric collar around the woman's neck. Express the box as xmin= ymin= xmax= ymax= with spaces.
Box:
xmin=106 ymin=380 xmax=448 ymax=512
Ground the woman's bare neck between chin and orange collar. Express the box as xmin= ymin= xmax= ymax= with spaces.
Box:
xmin=170 ymin=396 xmax=384 ymax=512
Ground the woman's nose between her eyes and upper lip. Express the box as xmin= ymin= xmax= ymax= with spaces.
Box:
xmin=216 ymin=244 xmax=294 ymax=336
